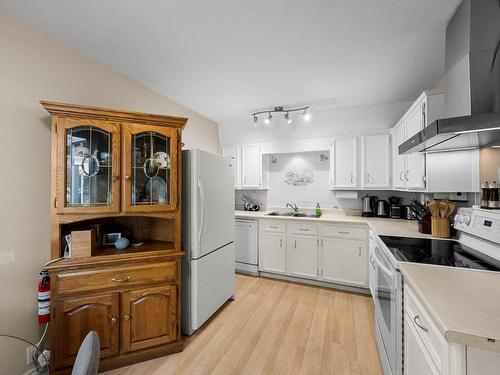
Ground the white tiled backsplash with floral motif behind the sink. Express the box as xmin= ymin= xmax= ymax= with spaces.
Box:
xmin=235 ymin=152 xmax=421 ymax=209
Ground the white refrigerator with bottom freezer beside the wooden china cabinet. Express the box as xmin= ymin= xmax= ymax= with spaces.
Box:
xmin=181 ymin=150 xmax=235 ymax=335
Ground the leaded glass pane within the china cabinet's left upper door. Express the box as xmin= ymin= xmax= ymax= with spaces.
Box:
xmin=66 ymin=126 xmax=112 ymax=207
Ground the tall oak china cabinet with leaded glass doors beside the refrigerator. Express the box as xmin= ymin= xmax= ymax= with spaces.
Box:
xmin=41 ymin=101 xmax=187 ymax=373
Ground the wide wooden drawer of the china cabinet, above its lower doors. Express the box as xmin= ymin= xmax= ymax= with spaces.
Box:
xmin=57 ymin=262 xmax=177 ymax=294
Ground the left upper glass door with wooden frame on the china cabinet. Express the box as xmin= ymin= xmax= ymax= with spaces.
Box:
xmin=57 ymin=119 xmax=120 ymax=213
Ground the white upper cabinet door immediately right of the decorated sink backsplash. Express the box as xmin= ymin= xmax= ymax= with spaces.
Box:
xmin=330 ymin=137 xmax=360 ymax=190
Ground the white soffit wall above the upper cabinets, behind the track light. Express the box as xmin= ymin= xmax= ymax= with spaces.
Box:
xmin=219 ymin=101 xmax=413 ymax=145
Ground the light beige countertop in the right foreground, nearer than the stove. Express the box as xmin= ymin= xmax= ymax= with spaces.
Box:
xmin=399 ymin=262 xmax=500 ymax=352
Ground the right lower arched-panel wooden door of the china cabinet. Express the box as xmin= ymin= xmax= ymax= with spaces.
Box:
xmin=121 ymin=285 xmax=179 ymax=352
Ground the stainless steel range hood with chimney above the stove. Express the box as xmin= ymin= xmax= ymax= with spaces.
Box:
xmin=398 ymin=0 xmax=500 ymax=154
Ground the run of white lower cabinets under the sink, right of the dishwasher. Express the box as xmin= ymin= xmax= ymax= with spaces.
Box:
xmin=259 ymin=220 xmax=368 ymax=288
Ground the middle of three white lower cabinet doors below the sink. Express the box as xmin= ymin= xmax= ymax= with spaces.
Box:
xmin=287 ymin=235 xmax=318 ymax=279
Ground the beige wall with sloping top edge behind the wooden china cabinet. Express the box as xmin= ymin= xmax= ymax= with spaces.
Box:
xmin=0 ymin=13 xmax=219 ymax=374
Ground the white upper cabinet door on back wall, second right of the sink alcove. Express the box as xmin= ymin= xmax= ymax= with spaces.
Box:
xmin=361 ymin=134 xmax=392 ymax=189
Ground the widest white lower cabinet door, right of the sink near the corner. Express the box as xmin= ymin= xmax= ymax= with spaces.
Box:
xmin=321 ymin=237 xmax=367 ymax=287
